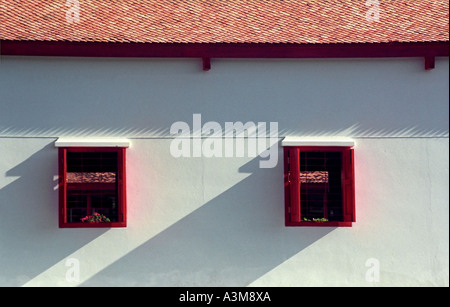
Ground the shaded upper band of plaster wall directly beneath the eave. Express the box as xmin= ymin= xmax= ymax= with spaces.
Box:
xmin=0 ymin=56 xmax=449 ymax=137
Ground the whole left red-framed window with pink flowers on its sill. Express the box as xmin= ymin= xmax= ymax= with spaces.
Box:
xmin=57 ymin=142 xmax=126 ymax=228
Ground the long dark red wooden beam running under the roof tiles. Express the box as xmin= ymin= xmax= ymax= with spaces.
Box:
xmin=0 ymin=41 xmax=449 ymax=58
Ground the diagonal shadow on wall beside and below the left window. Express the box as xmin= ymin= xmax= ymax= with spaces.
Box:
xmin=0 ymin=139 xmax=106 ymax=286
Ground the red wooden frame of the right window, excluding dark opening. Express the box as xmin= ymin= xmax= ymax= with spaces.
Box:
xmin=283 ymin=146 xmax=356 ymax=227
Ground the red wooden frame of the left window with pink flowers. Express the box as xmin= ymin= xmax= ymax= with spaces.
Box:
xmin=58 ymin=147 xmax=127 ymax=228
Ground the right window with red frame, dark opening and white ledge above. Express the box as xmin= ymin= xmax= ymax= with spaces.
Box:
xmin=283 ymin=139 xmax=355 ymax=226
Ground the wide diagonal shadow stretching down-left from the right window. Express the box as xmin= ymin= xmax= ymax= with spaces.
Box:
xmin=81 ymin=151 xmax=334 ymax=286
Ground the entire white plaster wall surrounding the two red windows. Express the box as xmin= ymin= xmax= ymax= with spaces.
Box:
xmin=0 ymin=57 xmax=449 ymax=286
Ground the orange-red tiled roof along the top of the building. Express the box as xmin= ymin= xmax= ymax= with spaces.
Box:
xmin=0 ymin=0 xmax=449 ymax=44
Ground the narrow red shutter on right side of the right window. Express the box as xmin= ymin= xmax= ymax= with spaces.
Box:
xmin=342 ymin=149 xmax=356 ymax=222
